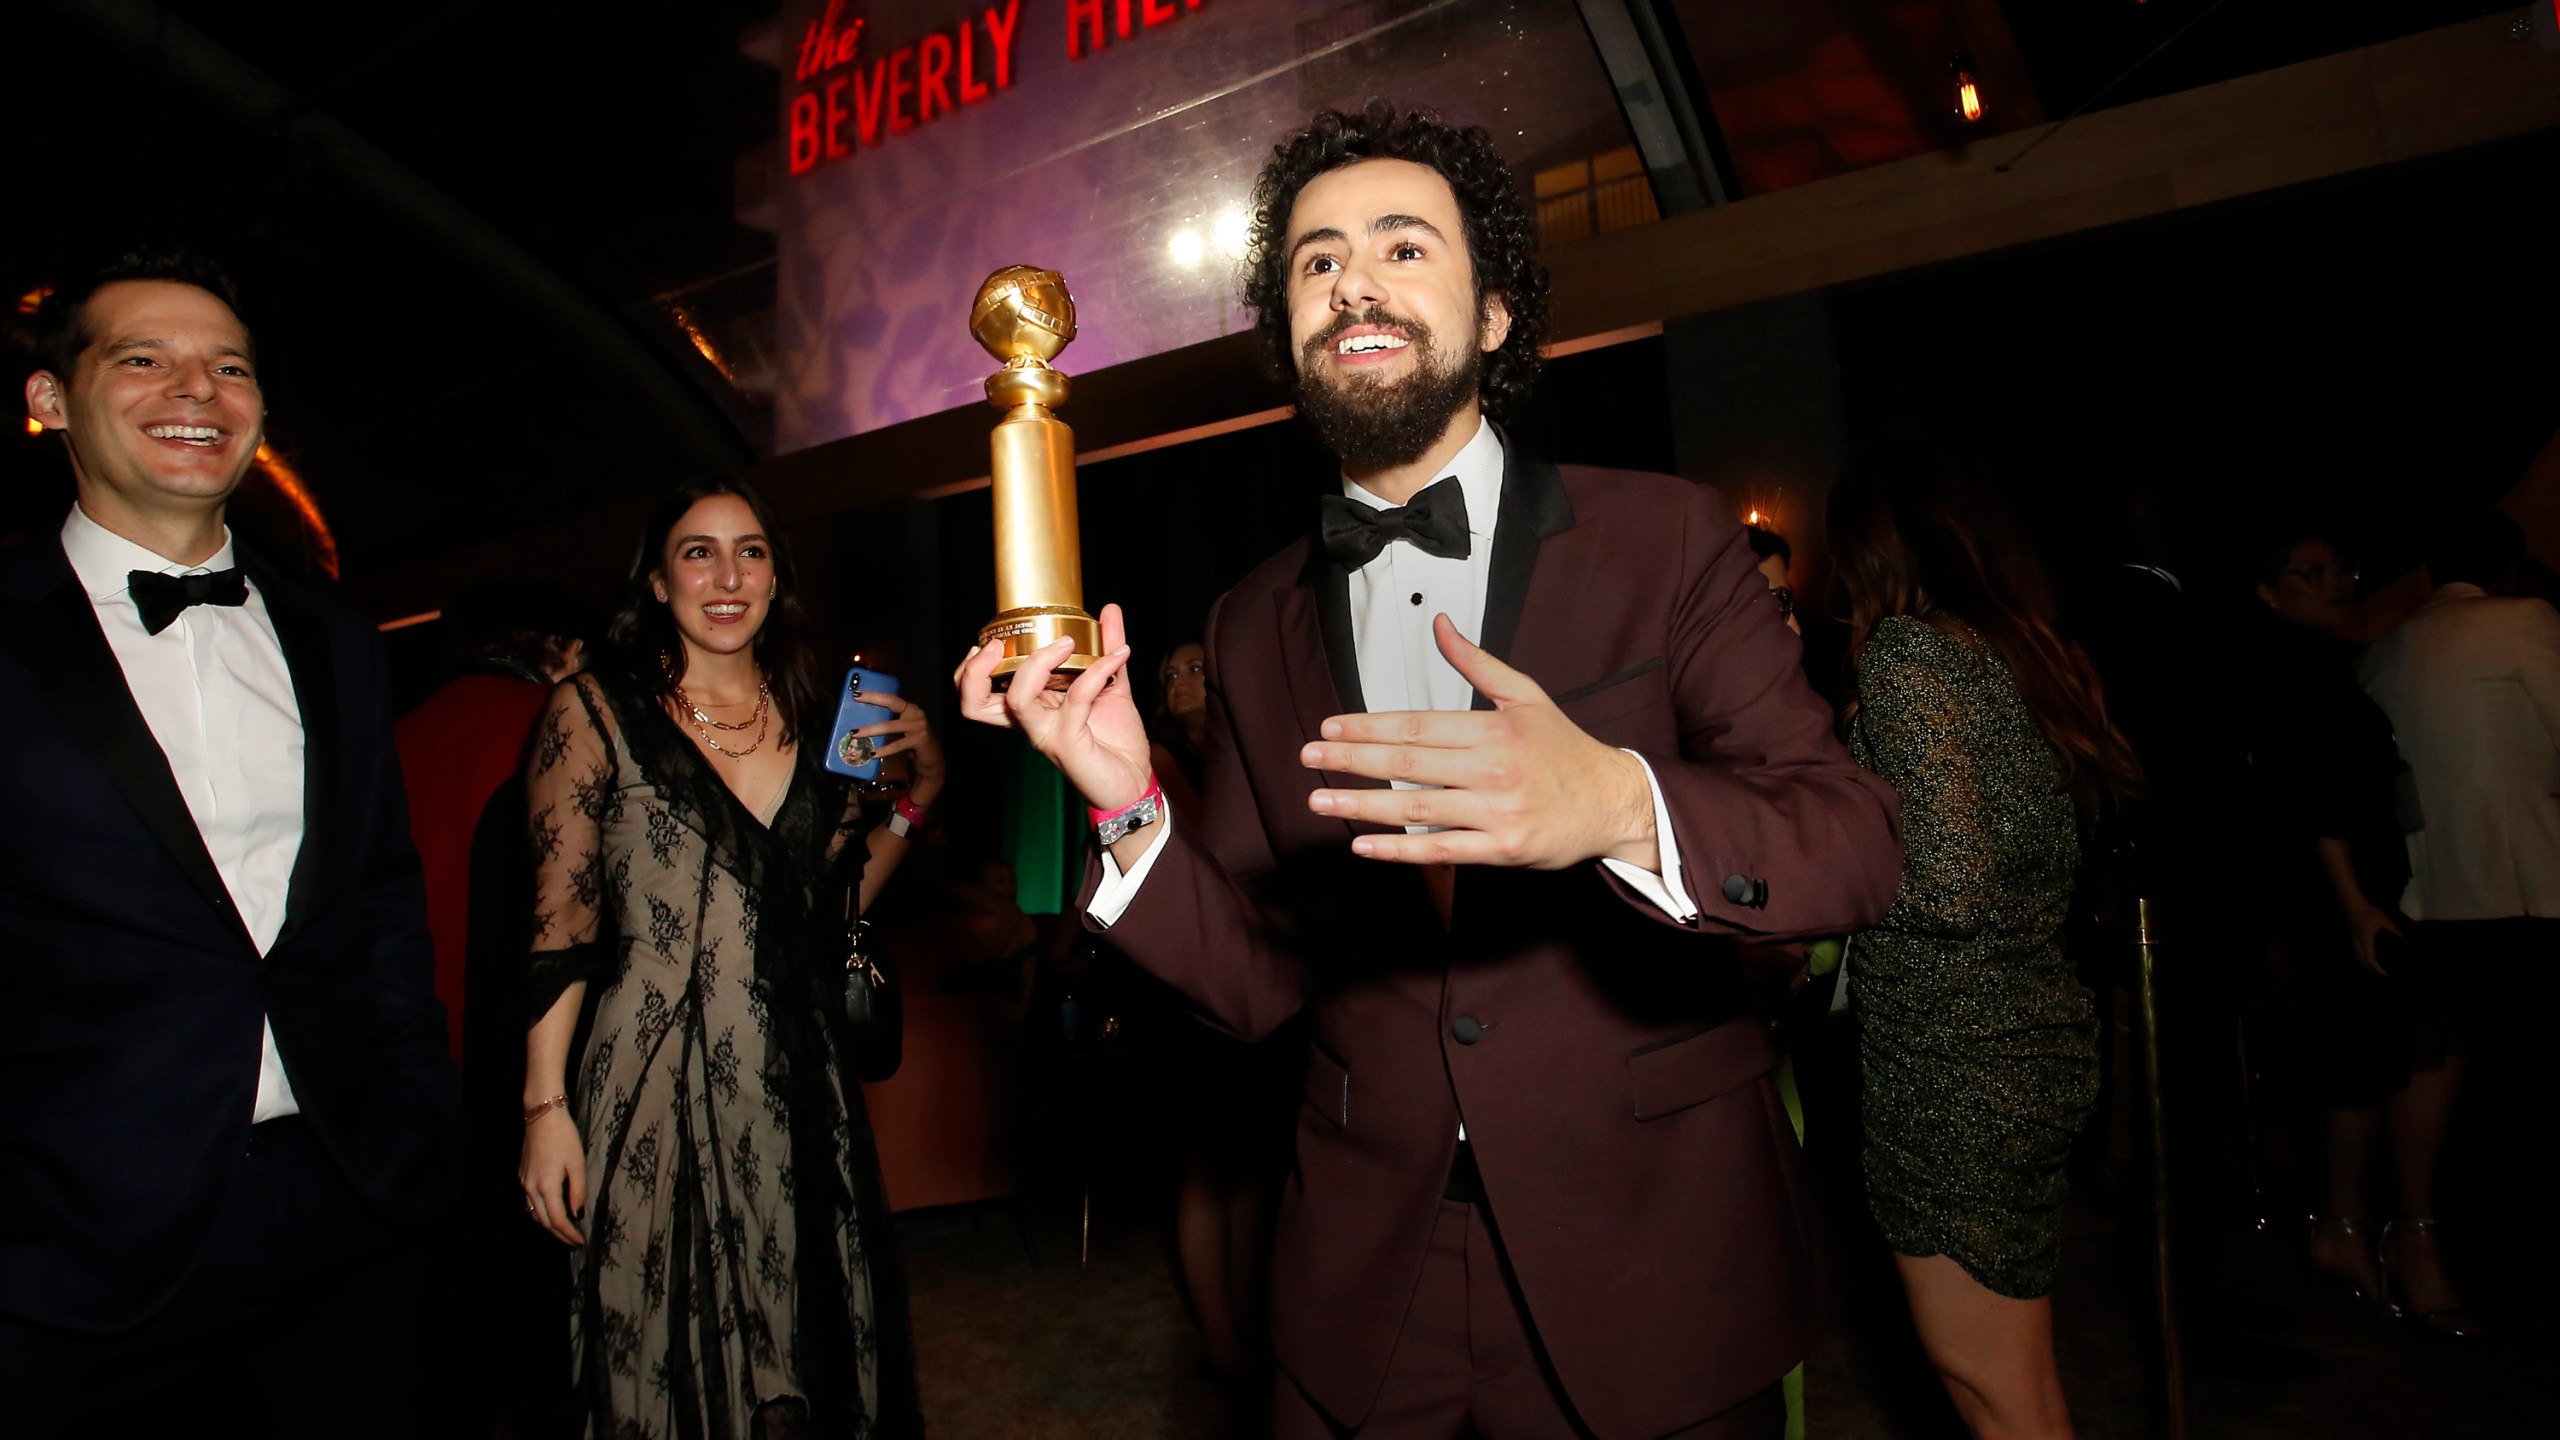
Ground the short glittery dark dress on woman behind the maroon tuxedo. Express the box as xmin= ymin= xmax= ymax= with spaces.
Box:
xmin=1848 ymin=615 xmax=2099 ymax=1299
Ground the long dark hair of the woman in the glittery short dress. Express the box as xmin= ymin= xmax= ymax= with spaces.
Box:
xmin=1825 ymin=456 xmax=2143 ymax=825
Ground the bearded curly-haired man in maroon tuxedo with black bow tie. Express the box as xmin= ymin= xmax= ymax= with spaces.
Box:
xmin=957 ymin=102 xmax=1902 ymax=1440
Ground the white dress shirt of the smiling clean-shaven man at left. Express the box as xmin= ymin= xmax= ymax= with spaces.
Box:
xmin=61 ymin=505 xmax=302 ymax=1122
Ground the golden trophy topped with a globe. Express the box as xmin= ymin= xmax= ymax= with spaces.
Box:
xmin=968 ymin=264 xmax=1103 ymax=689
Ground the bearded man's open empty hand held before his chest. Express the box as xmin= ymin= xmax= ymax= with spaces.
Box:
xmin=1298 ymin=615 xmax=1661 ymax=871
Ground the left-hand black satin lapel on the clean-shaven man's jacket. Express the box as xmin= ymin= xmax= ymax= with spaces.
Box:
xmin=0 ymin=548 xmax=256 ymax=951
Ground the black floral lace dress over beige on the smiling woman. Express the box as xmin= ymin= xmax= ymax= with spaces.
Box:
xmin=527 ymin=674 xmax=911 ymax=1440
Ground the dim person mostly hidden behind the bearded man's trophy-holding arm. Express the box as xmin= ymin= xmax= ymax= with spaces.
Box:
xmin=1149 ymin=638 xmax=1300 ymax=1381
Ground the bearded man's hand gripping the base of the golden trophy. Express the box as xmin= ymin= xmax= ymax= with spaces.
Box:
xmin=952 ymin=605 xmax=1155 ymax=810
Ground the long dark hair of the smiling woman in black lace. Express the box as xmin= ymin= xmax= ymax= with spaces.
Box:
xmin=604 ymin=477 xmax=835 ymax=746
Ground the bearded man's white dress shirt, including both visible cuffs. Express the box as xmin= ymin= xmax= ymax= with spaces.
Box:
xmin=1085 ymin=420 xmax=1697 ymax=928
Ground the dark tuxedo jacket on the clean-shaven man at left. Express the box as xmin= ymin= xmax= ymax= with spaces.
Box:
xmin=0 ymin=538 xmax=453 ymax=1332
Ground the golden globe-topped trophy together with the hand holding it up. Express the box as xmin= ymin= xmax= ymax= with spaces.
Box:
xmin=952 ymin=264 xmax=1152 ymax=810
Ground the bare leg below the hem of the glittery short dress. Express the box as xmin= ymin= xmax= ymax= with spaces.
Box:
xmin=1894 ymin=1256 xmax=2071 ymax=1440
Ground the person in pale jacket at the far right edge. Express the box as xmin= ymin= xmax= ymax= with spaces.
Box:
xmin=2363 ymin=510 xmax=2560 ymax=1332
